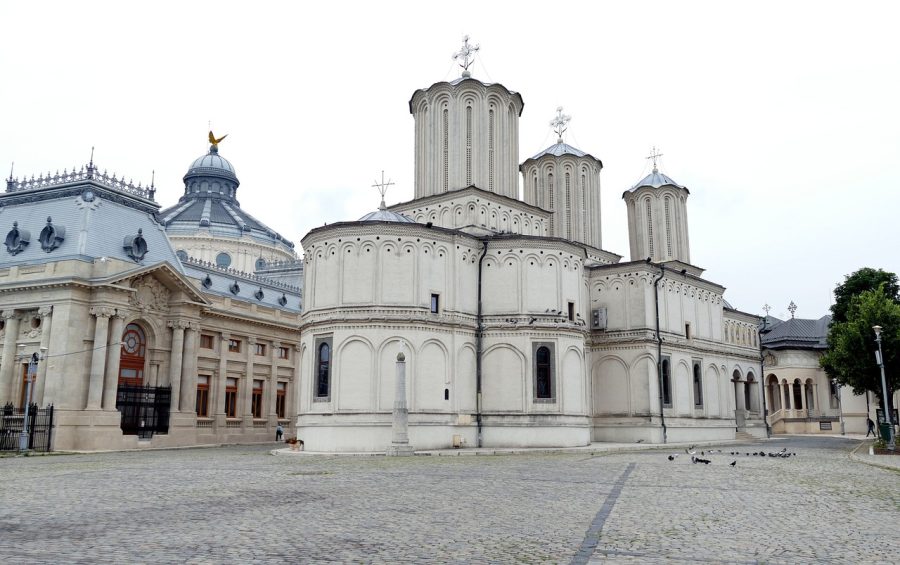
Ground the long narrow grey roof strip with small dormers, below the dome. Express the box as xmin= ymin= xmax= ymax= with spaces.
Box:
xmin=184 ymin=259 xmax=303 ymax=312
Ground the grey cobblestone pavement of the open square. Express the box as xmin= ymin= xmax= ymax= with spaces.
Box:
xmin=0 ymin=438 xmax=900 ymax=563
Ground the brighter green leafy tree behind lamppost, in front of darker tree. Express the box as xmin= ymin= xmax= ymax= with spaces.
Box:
xmin=820 ymin=284 xmax=900 ymax=398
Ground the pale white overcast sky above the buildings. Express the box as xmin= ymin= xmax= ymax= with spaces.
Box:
xmin=0 ymin=1 xmax=900 ymax=318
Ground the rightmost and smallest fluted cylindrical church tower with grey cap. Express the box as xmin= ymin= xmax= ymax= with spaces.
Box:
xmin=622 ymin=166 xmax=691 ymax=264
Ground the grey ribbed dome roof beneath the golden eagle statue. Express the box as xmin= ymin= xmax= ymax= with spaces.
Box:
xmin=160 ymin=145 xmax=294 ymax=249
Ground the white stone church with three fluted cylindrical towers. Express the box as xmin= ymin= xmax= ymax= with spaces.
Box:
xmin=297 ymin=43 xmax=765 ymax=451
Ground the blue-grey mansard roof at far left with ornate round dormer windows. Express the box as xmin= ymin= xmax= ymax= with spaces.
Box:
xmin=0 ymin=180 xmax=184 ymax=273
